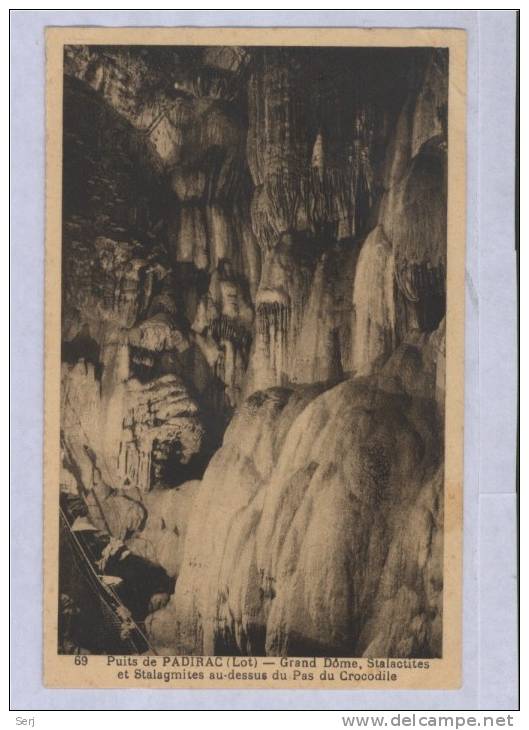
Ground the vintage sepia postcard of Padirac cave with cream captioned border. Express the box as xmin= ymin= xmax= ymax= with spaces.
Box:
xmin=44 ymin=28 xmax=466 ymax=689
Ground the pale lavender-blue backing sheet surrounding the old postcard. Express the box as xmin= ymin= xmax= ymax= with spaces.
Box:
xmin=11 ymin=10 xmax=517 ymax=711
